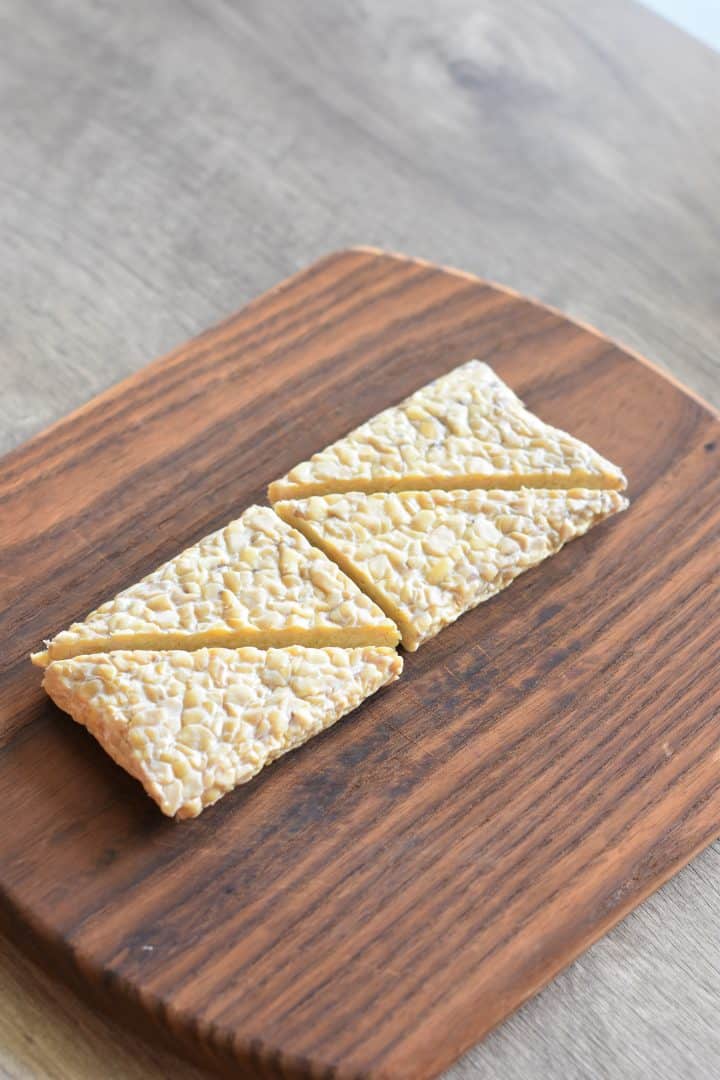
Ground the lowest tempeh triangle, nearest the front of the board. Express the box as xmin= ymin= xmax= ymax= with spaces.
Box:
xmin=43 ymin=646 xmax=403 ymax=818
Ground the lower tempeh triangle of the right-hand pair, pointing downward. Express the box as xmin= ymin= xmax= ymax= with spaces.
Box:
xmin=275 ymin=489 xmax=627 ymax=650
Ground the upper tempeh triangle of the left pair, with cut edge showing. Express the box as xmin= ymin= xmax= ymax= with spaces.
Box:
xmin=32 ymin=507 xmax=399 ymax=666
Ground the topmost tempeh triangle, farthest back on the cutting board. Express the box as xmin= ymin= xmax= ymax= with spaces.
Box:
xmin=269 ymin=360 xmax=626 ymax=502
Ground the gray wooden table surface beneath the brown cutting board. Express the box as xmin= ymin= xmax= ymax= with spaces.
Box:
xmin=0 ymin=0 xmax=720 ymax=1080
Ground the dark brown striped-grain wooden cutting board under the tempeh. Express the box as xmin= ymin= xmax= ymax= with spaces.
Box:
xmin=0 ymin=249 xmax=720 ymax=1080
